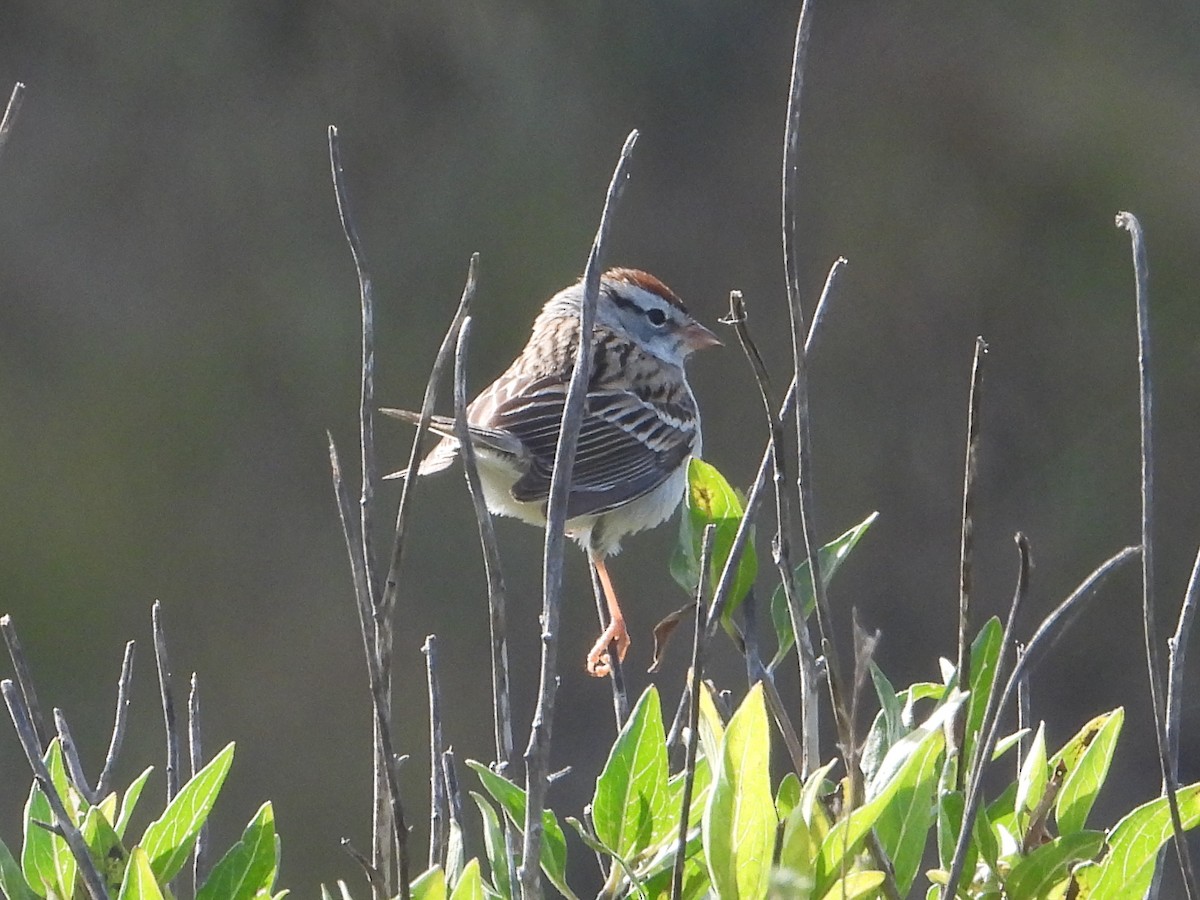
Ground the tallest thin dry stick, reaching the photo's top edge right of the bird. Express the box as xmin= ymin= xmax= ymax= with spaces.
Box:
xmin=781 ymin=0 xmax=863 ymax=787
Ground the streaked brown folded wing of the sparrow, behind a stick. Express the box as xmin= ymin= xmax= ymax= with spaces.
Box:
xmin=488 ymin=378 xmax=695 ymax=518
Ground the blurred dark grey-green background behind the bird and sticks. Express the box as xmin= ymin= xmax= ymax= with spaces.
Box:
xmin=0 ymin=0 xmax=1200 ymax=895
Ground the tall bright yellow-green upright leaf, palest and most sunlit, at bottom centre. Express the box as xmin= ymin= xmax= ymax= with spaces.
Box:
xmin=703 ymin=683 xmax=778 ymax=900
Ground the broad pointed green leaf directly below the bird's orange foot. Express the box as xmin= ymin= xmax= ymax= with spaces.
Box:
xmin=592 ymin=685 xmax=678 ymax=859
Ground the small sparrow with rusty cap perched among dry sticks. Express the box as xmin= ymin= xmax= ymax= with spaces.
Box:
xmin=382 ymin=269 xmax=720 ymax=677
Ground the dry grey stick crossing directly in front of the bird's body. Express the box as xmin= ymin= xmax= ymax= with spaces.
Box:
xmin=518 ymin=131 xmax=637 ymax=900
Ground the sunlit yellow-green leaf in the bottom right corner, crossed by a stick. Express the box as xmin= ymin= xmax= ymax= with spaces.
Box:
xmin=1078 ymin=784 xmax=1200 ymax=898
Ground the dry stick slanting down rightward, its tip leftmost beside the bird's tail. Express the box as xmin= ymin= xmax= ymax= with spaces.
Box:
xmin=329 ymin=437 xmax=410 ymax=900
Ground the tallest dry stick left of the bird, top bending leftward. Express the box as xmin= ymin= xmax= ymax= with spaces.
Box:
xmin=329 ymin=125 xmax=392 ymax=892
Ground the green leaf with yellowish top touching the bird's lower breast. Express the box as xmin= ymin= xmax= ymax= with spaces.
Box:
xmin=671 ymin=456 xmax=758 ymax=630
